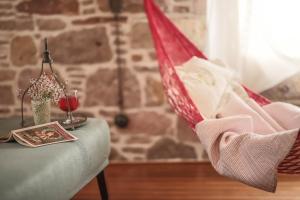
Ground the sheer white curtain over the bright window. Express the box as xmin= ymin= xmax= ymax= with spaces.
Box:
xmin=206 ymin=0 xmax=300 ymax=92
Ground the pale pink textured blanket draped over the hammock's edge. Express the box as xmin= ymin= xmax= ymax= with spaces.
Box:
xmin=196 ymin=93 xmax=300 ymax=192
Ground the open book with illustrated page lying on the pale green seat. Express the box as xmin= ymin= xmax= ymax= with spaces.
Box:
xmin=0 ymin=121 xmax=78 ymax=147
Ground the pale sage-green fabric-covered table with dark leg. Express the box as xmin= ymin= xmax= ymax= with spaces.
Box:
xmin=0 ymin=118 xmax=110 ymax=200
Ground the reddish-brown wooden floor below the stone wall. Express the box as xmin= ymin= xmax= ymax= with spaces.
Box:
xmin=74 ymin=163 xmax=300 ymax=200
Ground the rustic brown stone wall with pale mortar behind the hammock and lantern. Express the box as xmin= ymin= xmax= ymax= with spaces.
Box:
xmin=0 ymin=0 xmax=206 ymax=161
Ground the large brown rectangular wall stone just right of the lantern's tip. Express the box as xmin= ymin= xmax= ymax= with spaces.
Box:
xmin=49 ymin=27 xmax=112 ymax=64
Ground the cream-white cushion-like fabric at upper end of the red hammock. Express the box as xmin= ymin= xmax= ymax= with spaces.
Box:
xmin=175 ymin=57 xmax=237 ymax=117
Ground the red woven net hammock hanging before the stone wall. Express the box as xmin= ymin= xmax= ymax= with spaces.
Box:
xmin=144 ymin=0 xmax=300 ymax=174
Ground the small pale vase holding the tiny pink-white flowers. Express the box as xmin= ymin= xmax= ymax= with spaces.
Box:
xmin=31 ymin=99 xmax=51 ymax=125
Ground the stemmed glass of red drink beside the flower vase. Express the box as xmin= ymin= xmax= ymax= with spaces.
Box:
xmin=58 ymin=90 xmax=79 ymax=125
